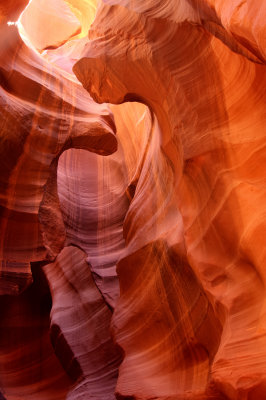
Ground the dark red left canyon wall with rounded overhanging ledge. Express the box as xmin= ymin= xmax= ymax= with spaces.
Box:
xmin=0 ymin=3 xmax=119 ymax=400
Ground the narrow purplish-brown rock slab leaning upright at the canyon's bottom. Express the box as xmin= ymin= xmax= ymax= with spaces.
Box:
xmin=44 ymin=246 xmax=120 ymax=400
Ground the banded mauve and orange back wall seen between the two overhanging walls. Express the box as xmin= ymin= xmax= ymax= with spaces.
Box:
xmin=58 ymin=103 xmax=150 ymax=308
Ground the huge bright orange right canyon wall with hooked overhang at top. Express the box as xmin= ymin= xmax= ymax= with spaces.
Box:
xmin=74 ymin=0 xmax=266 ymax=399
